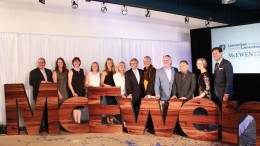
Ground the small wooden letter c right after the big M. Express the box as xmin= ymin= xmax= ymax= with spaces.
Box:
xmin=59 ymin=97 xmax=89 ymax=133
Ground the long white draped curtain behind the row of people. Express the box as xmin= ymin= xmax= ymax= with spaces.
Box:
xmin=0 ymin=33 xmax=191 ymax=125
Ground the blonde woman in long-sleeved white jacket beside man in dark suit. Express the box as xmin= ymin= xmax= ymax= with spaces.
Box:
xmin=113 ymin=61 xmax=126 ymax=98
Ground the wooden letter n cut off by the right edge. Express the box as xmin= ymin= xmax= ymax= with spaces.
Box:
xmin=222 ymin=101 xmax=260 ymax=146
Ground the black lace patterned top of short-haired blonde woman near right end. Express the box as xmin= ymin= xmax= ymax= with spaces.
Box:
xmin=198 ymin=72 xmax=211 ymax=99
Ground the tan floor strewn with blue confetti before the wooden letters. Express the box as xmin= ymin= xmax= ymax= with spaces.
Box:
xmin=0 ymin=131 xmax=232 ymax=146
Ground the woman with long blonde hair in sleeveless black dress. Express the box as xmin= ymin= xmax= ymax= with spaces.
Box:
xmin=100 ymin=58 xmax=117 ymax=124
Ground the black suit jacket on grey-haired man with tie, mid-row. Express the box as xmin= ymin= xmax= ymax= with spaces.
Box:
xmin=125 ymin=69 xmax=144 ymax=103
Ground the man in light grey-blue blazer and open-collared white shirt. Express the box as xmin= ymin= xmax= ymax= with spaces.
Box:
xmin=154 ymin=55 xmax=178 ymax=119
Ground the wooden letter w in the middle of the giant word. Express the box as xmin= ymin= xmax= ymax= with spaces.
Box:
xmin=118 ymin=98 xmax=182 ymax=137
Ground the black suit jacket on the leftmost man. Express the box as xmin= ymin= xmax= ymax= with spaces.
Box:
xmin=29 ymin=67 xmax=53 ymax=101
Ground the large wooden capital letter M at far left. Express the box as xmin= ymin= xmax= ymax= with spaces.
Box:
xmin=5 ymin=84 xmax=59 ymax=135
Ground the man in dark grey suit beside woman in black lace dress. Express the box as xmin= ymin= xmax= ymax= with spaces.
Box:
xmin=172 ymin=60 xmax=196 ymax=101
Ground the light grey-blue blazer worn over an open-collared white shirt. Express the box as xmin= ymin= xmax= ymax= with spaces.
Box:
xmin=154 ymin=67 xmax=178 ymax=101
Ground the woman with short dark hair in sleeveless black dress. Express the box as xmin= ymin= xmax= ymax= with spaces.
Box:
xmin=68 ymin=57 xmax=85 ymax=123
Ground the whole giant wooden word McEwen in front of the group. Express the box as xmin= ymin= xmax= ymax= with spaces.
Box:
xmin=4 ymin=84 xmax=260 ymax=145
